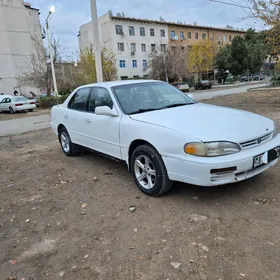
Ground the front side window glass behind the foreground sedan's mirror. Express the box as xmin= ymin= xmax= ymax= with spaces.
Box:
xmin=89 ymin=87 xmax=113 ymax=113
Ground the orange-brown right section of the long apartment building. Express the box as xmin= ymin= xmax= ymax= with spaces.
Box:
xmin=168 ymin=23 xmax=245 ymax=51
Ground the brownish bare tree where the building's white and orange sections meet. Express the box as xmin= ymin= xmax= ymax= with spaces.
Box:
xmin=149 ymin=47 xmax=187 ymax=82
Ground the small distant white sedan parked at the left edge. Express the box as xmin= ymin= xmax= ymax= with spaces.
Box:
xmin=0 ymin=95 xmax=36 ymax=114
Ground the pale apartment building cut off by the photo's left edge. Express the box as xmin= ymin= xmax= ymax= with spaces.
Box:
xmin=0 ymin=0 xmax=43 ymax=94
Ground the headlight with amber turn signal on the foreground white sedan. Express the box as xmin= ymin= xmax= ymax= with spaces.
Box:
xmin=184 ymin=142 xmax=240 ymax=157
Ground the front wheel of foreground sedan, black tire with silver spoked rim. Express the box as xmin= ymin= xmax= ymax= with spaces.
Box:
xmin=130 ymin=145 xmax=173 ymax=196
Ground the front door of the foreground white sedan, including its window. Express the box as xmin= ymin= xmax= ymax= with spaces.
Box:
xmin=83 ymin=87 xmax=121 ymax=159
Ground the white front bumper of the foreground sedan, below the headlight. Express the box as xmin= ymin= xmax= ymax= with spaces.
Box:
xmin=163 ymin=134 xmax=280 ymax=187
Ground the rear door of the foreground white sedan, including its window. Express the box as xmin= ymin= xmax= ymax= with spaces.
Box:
xmin=63 ymin=87 xmax=92 ymax=147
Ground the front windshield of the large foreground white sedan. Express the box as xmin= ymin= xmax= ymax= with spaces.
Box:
xmin=112 ymin=82 xmax=195 ymax=115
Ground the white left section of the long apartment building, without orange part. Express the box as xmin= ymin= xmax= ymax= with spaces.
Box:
xmin=78 ymin=13 xmax=168 ymax=79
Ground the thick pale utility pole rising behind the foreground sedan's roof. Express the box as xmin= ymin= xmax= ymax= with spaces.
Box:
xmin=90 ymin=0 xmax=103 ymax=83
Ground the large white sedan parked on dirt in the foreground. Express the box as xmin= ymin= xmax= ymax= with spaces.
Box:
xmin=51 ymin=80 xmax=280 ymax=196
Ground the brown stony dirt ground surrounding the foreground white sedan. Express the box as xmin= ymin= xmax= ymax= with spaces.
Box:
xmin=0 ymin=92 xmax=280 ymax=280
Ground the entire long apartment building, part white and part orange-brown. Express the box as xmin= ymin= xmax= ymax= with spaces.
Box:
xmin=78 ymin=12 xmax=245 ymax=79
